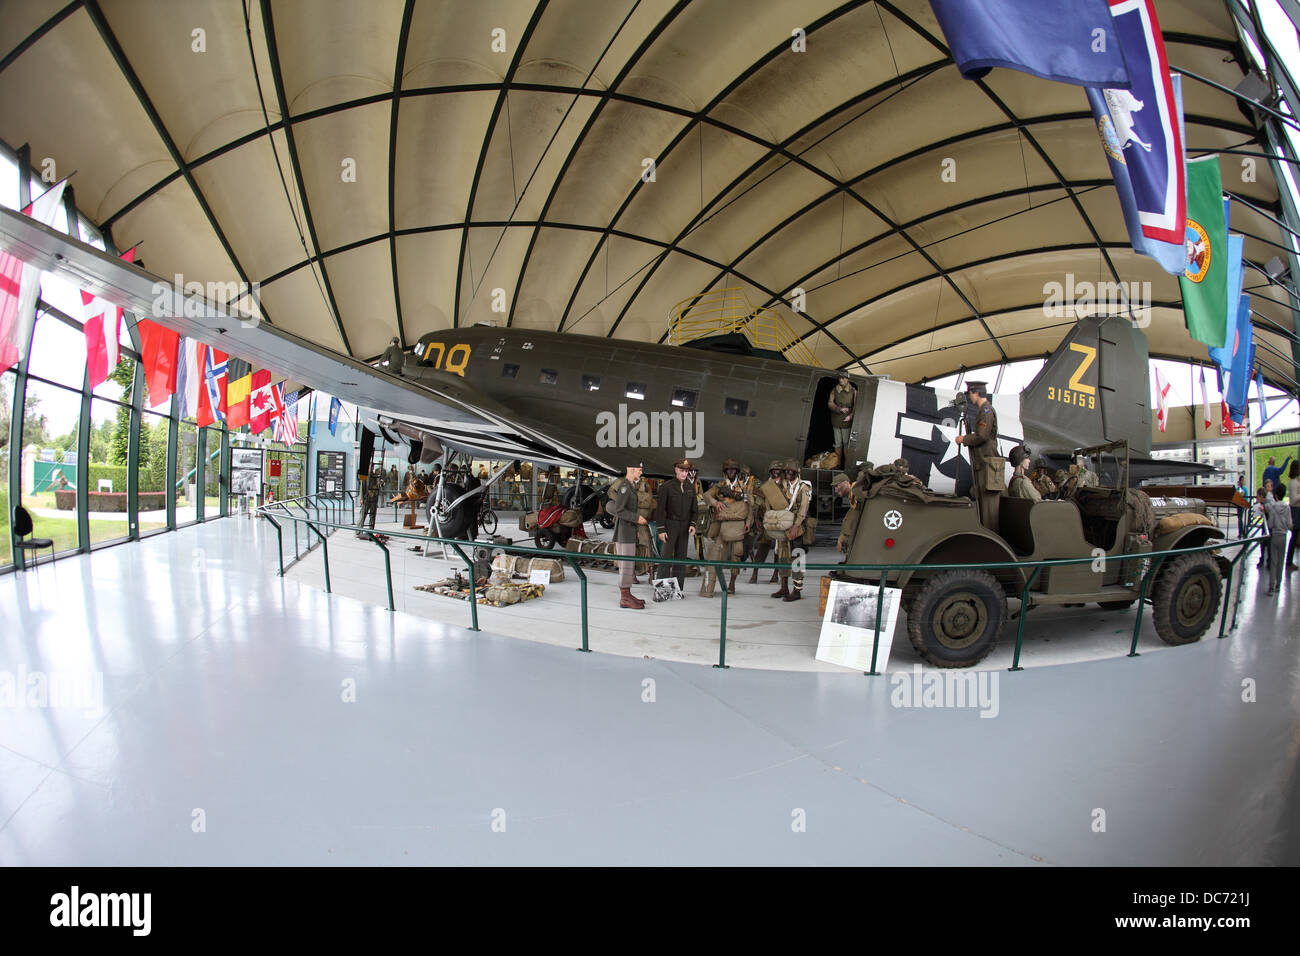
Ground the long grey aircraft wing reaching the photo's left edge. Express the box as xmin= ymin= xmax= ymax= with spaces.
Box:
xmin=0 ymin=207 xmax=615 ymax=472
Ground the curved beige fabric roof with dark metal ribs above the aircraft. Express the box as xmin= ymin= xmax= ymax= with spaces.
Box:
xmin=0 ymin=0 xmax=1295 ymax=384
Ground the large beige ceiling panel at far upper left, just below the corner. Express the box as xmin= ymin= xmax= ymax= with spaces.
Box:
xmin=0 ymin=10 xmax=170 ymax=221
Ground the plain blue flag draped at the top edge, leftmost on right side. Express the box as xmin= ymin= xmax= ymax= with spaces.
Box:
xmin=930 ymin=0 xmax=1131 ymax=88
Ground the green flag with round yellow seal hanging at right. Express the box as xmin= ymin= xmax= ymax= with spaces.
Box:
xmin=1178 ymin=156 xmax=1229 ymax=347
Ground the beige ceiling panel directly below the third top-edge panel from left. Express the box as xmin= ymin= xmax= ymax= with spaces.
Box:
xmin=293 ymin=103 xmax=391 ymax=252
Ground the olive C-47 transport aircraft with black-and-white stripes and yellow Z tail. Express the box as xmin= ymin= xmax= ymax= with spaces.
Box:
xmin=0 ymin=202 xmax=1205 ymax=493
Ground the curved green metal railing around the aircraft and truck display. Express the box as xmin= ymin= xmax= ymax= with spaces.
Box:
xmin=250 ymin=502 xmax=1268 ymax=676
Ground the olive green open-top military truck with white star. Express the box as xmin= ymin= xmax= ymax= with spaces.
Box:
xmin=835 ymin=442 xmax=1227 ymax=667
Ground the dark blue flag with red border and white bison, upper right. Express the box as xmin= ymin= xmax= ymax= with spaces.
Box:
xmin=1087 ymin=17 xmax=1187 ymax=276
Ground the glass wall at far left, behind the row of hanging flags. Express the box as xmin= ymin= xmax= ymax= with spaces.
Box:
xmin=0 ymin=138 xmax=240 ymax=571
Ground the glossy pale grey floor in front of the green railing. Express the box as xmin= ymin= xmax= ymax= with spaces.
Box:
xmin=0 ymin=519 xmax=1300 ymax=865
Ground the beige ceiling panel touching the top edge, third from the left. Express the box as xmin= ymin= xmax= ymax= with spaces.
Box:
xmin=269 ymin=0 xmax=403 ymax=116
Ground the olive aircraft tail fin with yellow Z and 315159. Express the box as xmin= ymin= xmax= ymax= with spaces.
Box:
xmin=1021 ymin=316 xmax=1151 ymax=455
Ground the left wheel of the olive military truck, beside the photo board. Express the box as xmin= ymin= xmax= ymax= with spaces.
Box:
xmin=907 ymin=571 xmax=1006 ymax=667
